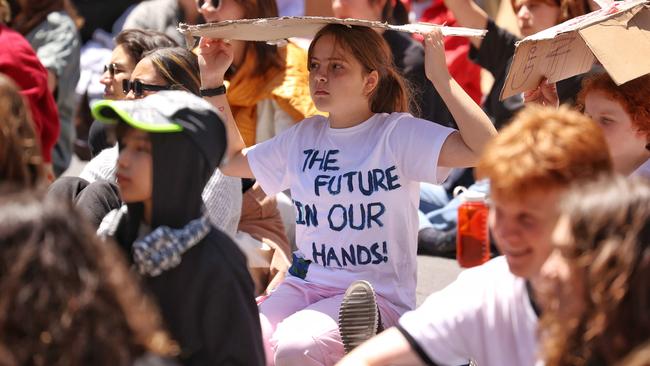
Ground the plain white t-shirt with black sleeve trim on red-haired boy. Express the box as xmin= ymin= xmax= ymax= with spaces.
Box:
xmin=399 ymin=256 xmax=538 ymax=366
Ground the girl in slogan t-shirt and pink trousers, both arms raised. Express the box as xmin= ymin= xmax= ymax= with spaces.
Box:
xmin=199 ymin=25 xmax=496 ymax=365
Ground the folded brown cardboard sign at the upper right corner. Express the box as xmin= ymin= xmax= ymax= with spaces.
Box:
xmin=501 ymin=0 xmax=650 ymax=99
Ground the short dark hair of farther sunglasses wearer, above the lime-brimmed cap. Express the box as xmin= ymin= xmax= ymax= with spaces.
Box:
xmin=115 ymin=29 xmax=178 ymax=64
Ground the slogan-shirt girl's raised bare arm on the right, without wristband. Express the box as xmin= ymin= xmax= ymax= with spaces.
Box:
xmin=424 ymin=29 xmax=497 ymax=168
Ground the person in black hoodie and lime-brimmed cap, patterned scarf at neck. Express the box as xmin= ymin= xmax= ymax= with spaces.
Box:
xmin=93 ymin=91 xmax=264 ymax=366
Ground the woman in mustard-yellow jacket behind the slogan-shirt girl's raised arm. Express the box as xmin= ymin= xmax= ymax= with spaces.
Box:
xmin=196 ymin=0 xmax=317 ymax=294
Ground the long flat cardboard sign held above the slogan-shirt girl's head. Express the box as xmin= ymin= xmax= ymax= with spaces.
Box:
xmin=178 ymin=17 xmax=486 ymax=43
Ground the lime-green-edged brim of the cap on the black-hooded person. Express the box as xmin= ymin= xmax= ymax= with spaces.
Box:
xmin=92 ymin=100 xmax=183 ymax=133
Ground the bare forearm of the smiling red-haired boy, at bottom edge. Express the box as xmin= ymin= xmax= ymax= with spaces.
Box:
xmin=336 ymin=328 xmax=422 ymax=366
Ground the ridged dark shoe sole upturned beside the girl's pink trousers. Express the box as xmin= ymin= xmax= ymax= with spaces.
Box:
xmin=339 ymin=281 xmax=379 ymax=353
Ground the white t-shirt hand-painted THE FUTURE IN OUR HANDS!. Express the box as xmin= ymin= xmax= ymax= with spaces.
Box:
xmin=248 ymin=113 xmax=454 ymax=312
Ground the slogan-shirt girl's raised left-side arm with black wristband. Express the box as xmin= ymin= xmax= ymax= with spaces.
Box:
xmin=198 ymin=38 xmax=253 ymax=178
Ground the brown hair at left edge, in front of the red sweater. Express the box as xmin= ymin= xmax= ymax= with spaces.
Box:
xmin=0 ymin=73 xmax=45 ymax=187
